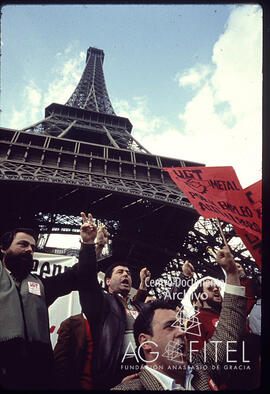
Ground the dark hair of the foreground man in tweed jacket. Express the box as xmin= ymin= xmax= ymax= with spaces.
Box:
xmin=133 ymin=299 xmax=176 ymax=347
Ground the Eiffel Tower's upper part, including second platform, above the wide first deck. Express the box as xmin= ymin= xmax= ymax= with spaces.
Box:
xmin=21 ymin=47 xmax=150 ymax=154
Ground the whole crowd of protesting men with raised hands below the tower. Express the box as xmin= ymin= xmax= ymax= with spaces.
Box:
xmin=0 ymin=212 xmax=261 ymax=391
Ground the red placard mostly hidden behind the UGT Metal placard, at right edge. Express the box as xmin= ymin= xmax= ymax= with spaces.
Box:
xmin=234 ymin=181 xmax=262 ymax=268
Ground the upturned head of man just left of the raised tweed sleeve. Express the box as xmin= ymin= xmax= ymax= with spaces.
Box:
xmin=192 ymin=279 xmax=222 ymax=312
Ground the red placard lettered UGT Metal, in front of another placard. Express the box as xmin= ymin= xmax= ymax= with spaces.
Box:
xmin=164 ymin=166 xmax=261 ymax=237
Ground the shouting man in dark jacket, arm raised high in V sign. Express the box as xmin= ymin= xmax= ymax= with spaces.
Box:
xmin=76 ymin=212 xmax=150 ymax=390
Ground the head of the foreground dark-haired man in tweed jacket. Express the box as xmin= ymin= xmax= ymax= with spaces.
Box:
xmin=134 ymin=299 xmax=188 ymax=378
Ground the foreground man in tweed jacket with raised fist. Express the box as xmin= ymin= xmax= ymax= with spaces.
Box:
xmin=113 ymin=247 xmax=246 ymax=391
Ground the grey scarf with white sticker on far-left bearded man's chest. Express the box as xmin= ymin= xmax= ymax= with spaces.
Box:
xmin=0 ymin=261 xmax=50 ymax=343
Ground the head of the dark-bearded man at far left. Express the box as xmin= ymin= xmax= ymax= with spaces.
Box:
xmin=0 ymin=228 xmax=37 ymax=280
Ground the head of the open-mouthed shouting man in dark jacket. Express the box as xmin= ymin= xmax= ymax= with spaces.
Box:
xmin=104 ymin=263 xmax=132 ymax=296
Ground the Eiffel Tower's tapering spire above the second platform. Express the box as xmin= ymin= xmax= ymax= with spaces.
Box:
xmin=66 ymin=47 xmax=115 ymax=115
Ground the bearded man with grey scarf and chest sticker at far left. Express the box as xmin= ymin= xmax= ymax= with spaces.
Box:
xmin=0 ymin=228 xmax=86 ymax=390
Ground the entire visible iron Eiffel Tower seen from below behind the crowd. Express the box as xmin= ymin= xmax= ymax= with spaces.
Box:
xmin=0 ymin=47 xmax=256 ymax=285
